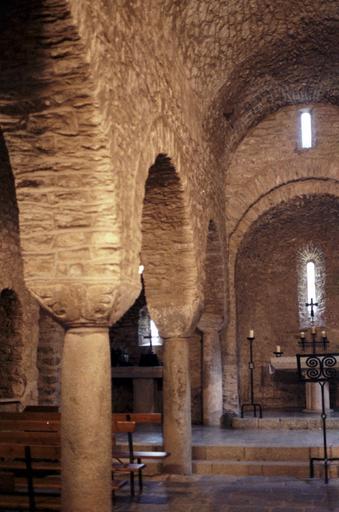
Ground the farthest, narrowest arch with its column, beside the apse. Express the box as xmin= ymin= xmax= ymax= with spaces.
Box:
xmin=195 ymin=220 xmax=226 ymax=425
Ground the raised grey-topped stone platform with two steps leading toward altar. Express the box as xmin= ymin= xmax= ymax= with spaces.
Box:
xmin=117 ymin=425 xmax=339 ymax=479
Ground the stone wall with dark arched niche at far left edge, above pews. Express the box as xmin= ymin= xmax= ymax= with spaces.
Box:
xmin=0 ymin=140 xmax=39 ymax=405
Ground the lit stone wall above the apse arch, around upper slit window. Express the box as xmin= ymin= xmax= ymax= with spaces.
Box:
xmin=226 ymin=104 xmax=339 ymax=236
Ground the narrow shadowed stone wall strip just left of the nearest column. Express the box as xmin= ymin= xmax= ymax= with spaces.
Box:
xmin=37 ymin=308 xmax=65 ymax=405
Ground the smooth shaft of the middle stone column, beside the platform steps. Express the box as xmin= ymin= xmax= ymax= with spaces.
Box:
xmin=163 ymin=338 xmax=192 ymax=475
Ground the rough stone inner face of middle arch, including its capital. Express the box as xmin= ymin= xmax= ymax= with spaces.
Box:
xmin=141 ymin=154 xmax=200 ymax=337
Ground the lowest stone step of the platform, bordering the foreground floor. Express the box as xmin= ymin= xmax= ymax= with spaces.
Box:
xmin=192 ymin=459 xmax=339 ymax=479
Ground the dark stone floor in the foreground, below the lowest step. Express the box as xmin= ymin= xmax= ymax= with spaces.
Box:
xmin=114 ymin=476 xmax=339 ymax=512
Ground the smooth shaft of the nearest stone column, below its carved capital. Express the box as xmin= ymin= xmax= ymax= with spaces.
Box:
xmin=61 ymin=327 xmax=112 ymax=512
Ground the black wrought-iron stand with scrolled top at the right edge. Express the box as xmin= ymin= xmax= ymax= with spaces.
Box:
xmin=296 ymin=354 xmax=339 ymax=484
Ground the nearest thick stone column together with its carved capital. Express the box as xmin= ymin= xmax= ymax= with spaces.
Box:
xmin=28 ymin=282 xmax=139 ymax=512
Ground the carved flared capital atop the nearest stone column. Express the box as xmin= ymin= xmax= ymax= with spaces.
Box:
xmin=27 ymin=281 xmax=140 ymax=327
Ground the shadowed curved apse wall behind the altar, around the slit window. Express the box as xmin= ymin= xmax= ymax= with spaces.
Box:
xmin=236 ymin=195 xmax=339 ymax=408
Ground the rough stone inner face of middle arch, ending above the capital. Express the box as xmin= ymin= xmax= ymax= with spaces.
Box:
xmin=141 ymin=154 xmax=195 ymax=314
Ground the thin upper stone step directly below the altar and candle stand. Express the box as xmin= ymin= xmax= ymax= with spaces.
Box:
xmin=232 ymin=413 xmax=339 ymax=430
